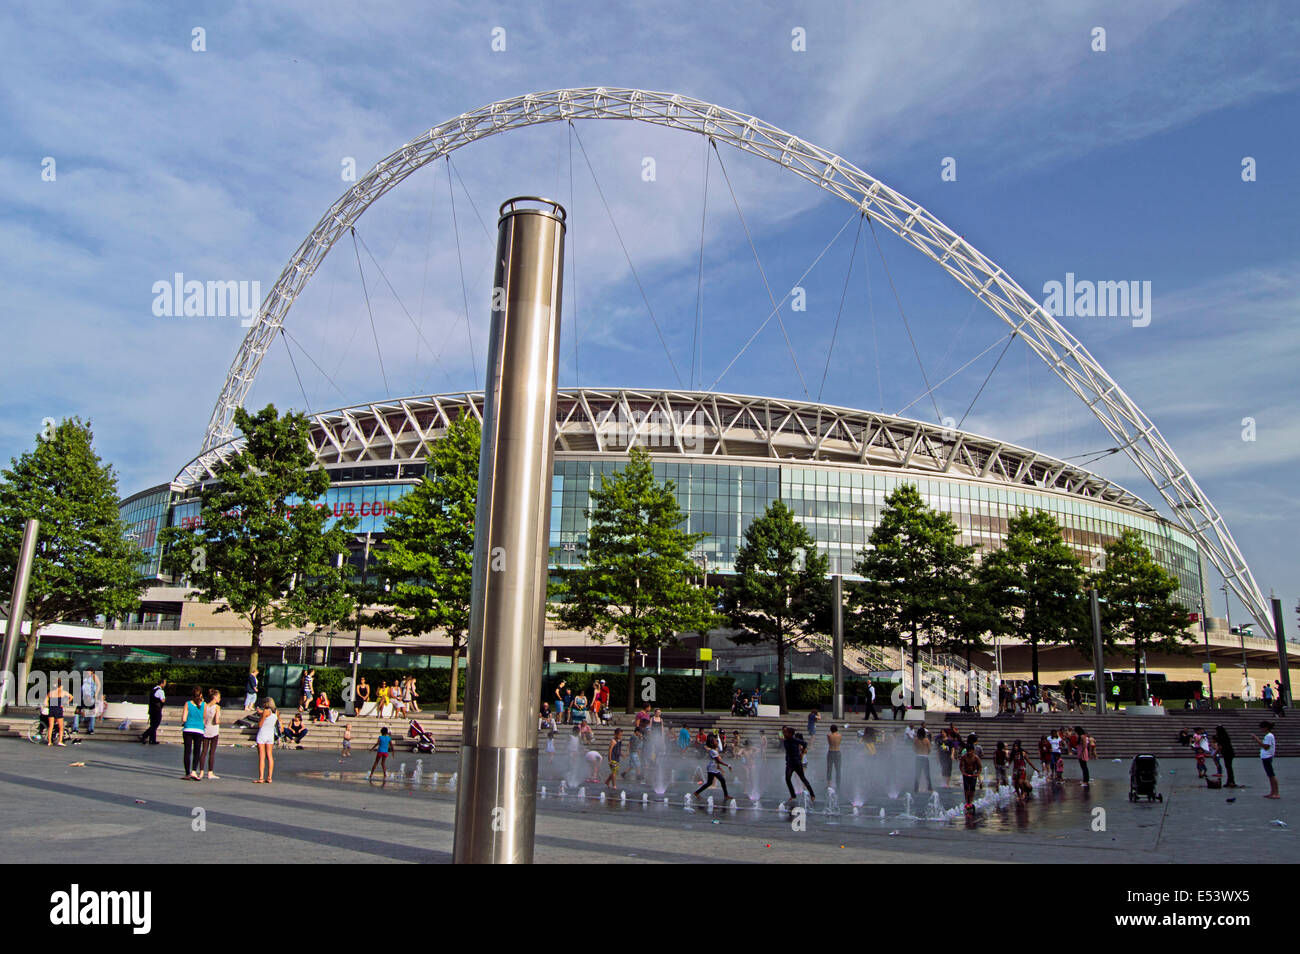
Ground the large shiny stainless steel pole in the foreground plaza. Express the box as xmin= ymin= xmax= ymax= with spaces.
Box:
xmin=452 ymin=198 xmax=564 ymax=864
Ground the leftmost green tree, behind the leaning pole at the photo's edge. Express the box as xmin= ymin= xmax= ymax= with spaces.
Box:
xmin=0 ymin=419 xmax=146 ymax=671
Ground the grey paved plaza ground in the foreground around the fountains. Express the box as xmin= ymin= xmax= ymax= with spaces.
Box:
xmin=0 ymin=738 xmax=1300 ymax=863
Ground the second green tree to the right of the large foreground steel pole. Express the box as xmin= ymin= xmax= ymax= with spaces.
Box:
xmin=725 ymin=500 xmax=831 ymax=714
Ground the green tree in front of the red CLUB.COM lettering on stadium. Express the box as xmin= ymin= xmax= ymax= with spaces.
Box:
xmin=164 ymin=404 xmax=356 ymax=672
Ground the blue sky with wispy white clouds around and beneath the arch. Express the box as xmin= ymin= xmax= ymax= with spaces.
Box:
xmin=0 ymin=0 xmax=1300 ymax=625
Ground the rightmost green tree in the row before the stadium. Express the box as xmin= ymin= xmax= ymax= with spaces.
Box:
xmin=1096 ymin=530 xmax=1196 ymax=699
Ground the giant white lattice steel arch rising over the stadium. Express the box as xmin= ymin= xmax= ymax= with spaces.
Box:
xmin=192 ymin=87 xmax=1273 ymax=630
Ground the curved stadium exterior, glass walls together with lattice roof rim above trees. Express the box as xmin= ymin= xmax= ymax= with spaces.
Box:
xmin=121 ymin=387 xmax=1208 ymax=607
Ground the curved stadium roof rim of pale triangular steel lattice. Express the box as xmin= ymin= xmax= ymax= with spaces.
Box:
xmin=173 ymin=387 xmax=1156 ymax=513
